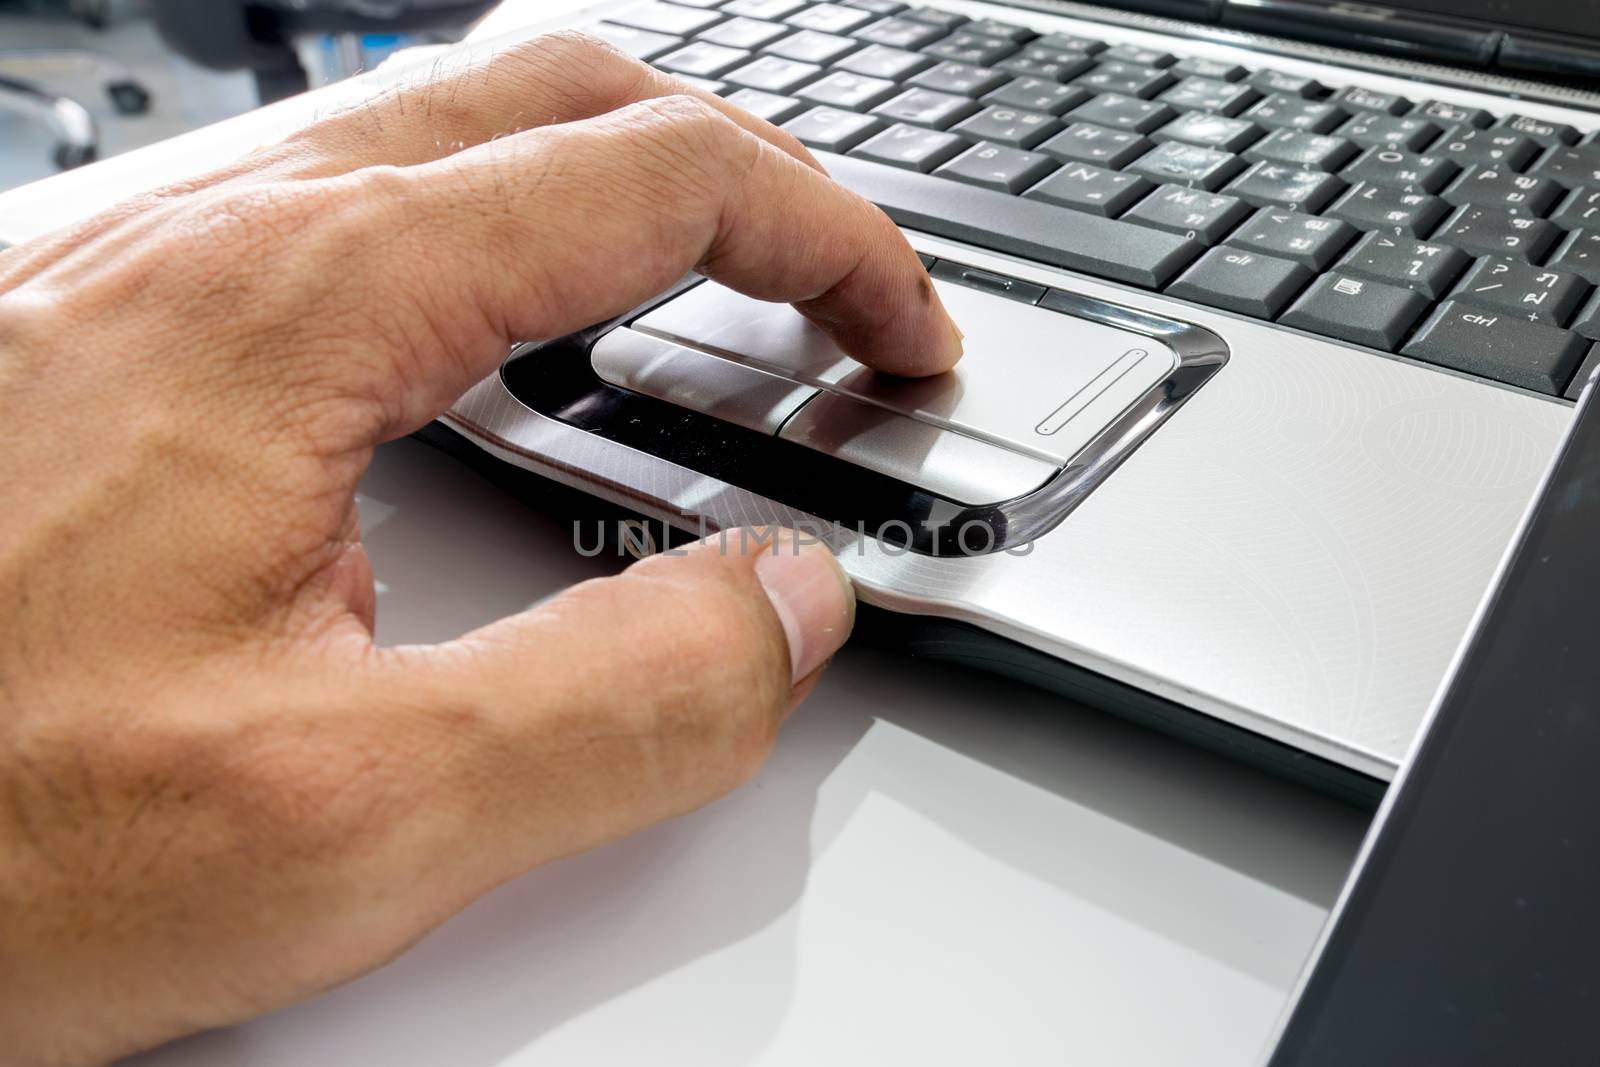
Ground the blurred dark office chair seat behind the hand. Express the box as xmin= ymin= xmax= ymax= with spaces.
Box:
xmin=149 ymin=0 xmax=496 ymax=104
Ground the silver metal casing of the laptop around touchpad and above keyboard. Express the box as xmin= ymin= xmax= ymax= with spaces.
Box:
xmin=446 ymin=0 xmax=1600 ymax=777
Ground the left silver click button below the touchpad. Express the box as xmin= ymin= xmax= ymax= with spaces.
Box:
xmin=589 ymin=330 xmax=816 ymax=434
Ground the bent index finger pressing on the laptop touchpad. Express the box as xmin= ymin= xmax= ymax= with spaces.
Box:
xmin=318 ymin=98 xmax=962 ymax=432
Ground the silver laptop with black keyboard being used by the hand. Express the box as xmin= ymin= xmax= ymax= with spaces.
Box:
xmin=430 ymin=0 xmax=1600 ymax=801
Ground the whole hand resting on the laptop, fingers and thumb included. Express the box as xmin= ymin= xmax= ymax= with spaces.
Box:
xmin=0 ymin=35 xmax=960 ymax=1064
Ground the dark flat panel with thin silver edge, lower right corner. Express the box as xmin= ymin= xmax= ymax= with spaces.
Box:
xmin=1261 ymin=364 xmax=1600 ymax=1067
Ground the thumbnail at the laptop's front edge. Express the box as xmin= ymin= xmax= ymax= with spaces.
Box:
xmin=755 ymin=530 xmax=856 ymax=683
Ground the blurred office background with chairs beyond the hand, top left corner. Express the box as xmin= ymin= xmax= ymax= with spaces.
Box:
xmin=0 ymin=0 xmax=494 ymax=190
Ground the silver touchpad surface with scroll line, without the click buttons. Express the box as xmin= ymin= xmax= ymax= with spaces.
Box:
xmin=634 ymin=280 xmax=1178 ymax=463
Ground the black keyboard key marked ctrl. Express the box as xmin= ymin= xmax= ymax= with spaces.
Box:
xmin=1403 ymin=301 xmax=1589 ymax=397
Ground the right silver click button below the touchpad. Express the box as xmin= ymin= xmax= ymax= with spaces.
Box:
xmin=779 ymin=394 xmax=1059 ymax=508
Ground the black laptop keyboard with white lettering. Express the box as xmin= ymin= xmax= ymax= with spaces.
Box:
xmin=589 ymin=0 xmax=1600 ymax=397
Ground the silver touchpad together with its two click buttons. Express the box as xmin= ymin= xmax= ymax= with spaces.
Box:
xmin=590 ymin=262 xmax=1209 ymax=504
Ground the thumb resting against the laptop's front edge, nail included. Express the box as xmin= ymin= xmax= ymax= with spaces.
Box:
xmin=353 ymin=530 xmax=854 ymax=907
